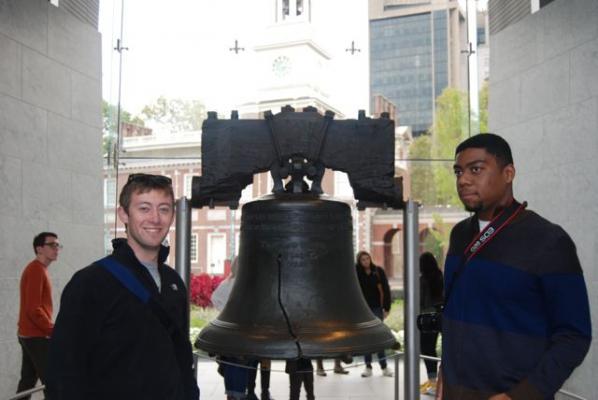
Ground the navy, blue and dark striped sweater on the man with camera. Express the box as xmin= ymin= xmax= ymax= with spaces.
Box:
xmin=442 ymin=211 xmax=591 ymax=400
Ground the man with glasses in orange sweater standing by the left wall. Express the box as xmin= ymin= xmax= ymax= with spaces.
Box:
xmin=17 ymin=232 xmax=62 ymax=399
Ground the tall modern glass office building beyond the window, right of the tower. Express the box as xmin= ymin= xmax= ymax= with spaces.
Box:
xmin=369 ymin=0 xmax=467 ymax=136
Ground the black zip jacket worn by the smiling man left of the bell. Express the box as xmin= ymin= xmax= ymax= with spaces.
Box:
xmin=46 ymin=239 xmax=199 ymax=400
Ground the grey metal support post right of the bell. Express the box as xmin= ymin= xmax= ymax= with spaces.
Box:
xmin=403 ymin=199 xmax=420 ymax=400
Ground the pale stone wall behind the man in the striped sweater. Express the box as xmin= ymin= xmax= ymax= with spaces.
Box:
xmin=489 ymin=0 xmax=598 ymax=399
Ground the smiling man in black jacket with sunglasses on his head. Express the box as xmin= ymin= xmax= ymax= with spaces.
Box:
xmin=48 ymin=174 xmax=199 ymax=400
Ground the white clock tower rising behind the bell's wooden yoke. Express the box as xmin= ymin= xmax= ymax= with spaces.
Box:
xmin=239 ymin=0 xmax=357 ymax=118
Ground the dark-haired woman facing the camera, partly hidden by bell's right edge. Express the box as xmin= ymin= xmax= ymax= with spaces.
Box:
xmin=355 ymin=251 xmax=393 ymax=378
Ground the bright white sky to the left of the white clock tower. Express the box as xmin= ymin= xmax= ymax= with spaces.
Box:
xmin=99 ymin=0 xmax=486 ymax=118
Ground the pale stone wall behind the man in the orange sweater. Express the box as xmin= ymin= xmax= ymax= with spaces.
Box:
xmin=0 ymin=0 xmax=103 ymax=398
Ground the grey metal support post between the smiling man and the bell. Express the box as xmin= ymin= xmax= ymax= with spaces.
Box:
xmin=175 ymin=196 xmax=191 ymax=290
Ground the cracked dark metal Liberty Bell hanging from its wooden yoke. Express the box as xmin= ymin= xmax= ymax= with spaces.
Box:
xmin=191 ymin=107 xmax=404 ymax=359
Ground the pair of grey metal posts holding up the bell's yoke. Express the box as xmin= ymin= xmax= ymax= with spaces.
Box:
xmin=175 ymin=196 xmax=420 ymax=400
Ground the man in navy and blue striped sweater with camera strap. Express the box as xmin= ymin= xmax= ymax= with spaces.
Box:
xmin=437 ymin=133 xmax=591 ymax=400
